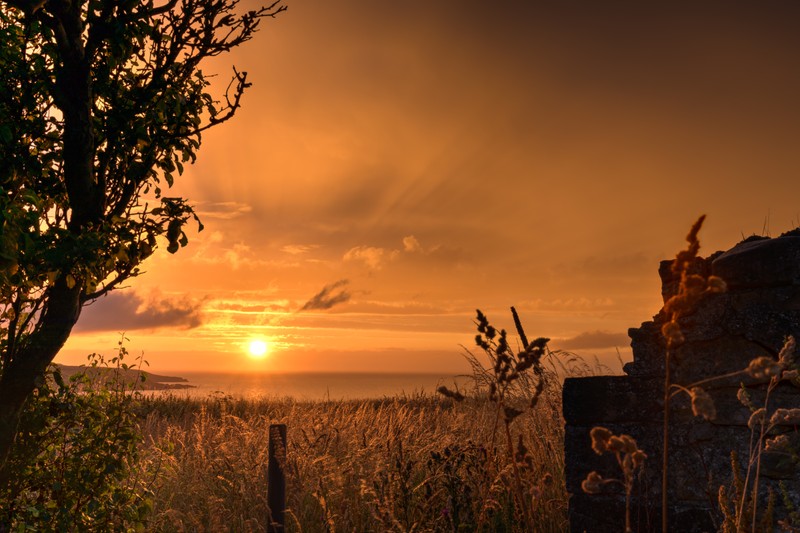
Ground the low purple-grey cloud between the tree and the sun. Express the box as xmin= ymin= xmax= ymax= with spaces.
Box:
xmin=75 ymin=291 xmax=202 ymax=332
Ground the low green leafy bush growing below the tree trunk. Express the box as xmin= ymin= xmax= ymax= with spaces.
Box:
xmin=0 ymin=343 xmax=152 ymax=531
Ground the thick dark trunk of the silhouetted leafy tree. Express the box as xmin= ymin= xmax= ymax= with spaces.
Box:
xmin=0 ymin=0 xmax=95 ymax=490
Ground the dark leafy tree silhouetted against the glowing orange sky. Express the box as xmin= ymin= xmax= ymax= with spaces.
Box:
xmin=0 ymin=0 xmax=286 ymax=487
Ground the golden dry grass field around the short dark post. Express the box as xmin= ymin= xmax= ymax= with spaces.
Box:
xmin=133 ymin=390 xmax=567 ymax=532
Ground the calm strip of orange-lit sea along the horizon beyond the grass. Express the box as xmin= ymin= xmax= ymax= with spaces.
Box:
xmin=146 ymin=372 xmax=471 ymax=401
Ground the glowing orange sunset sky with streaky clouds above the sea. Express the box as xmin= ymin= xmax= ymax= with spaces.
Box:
xmin=56 ymin=0 xmax=800 ymax=373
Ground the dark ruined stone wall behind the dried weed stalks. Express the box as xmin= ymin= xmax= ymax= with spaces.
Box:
xmin=564 ymin=233 xmax=800 ymax=533
